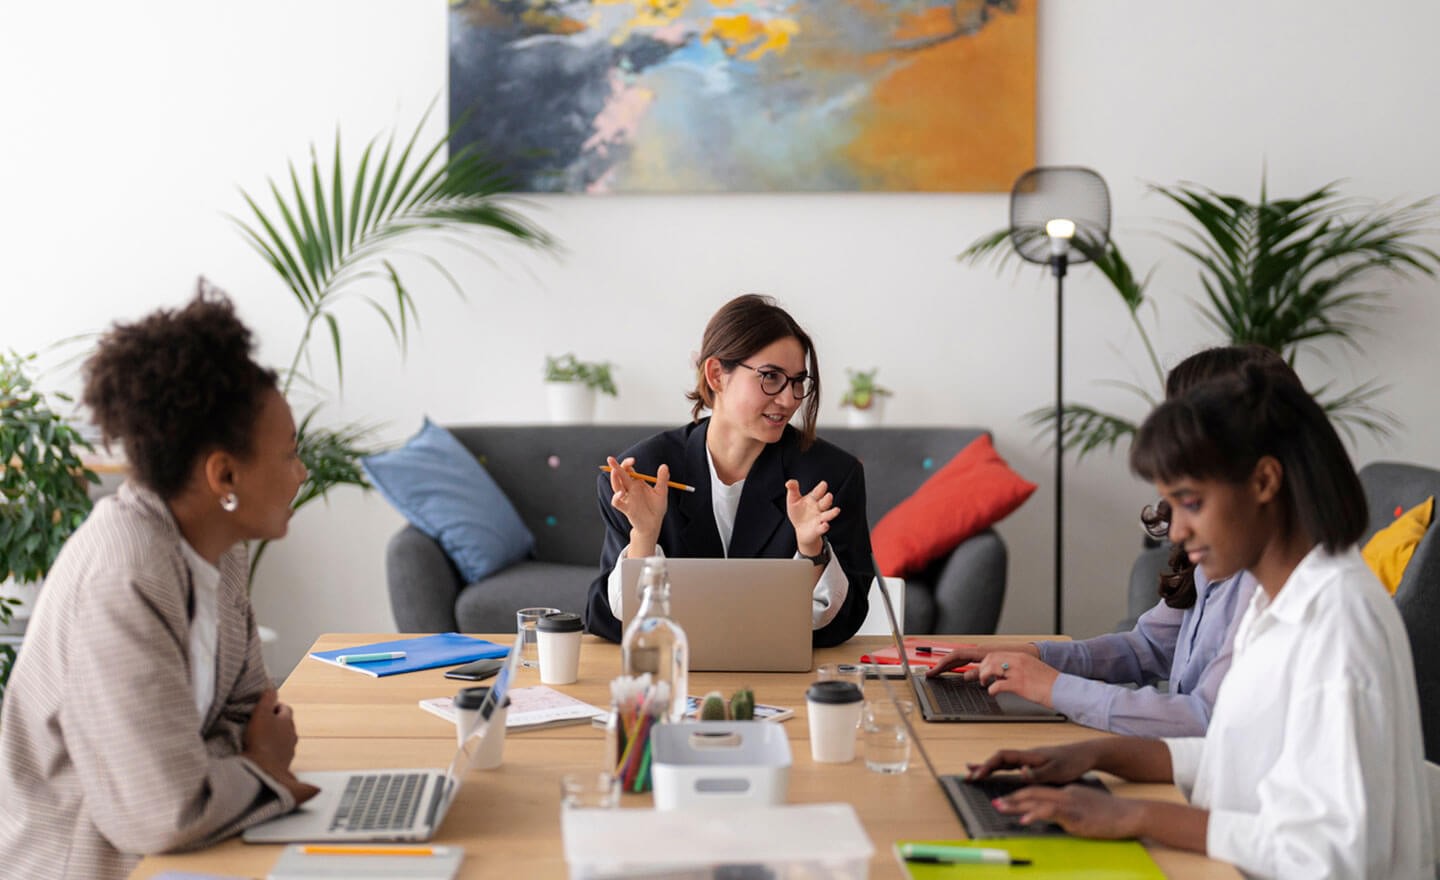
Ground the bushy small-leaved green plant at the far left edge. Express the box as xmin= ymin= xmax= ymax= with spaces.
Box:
xmin=0 ymin=353 xmax=99 ymax=697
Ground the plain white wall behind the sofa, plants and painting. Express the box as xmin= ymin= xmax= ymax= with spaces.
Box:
xmin=0 ymin=0 xmax=1440 ymax=673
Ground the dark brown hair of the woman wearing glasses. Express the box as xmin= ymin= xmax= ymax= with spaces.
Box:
xmin=685 ymin=294 xmax=819 ymax=449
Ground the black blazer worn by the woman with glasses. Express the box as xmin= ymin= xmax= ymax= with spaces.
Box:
xmin=585 ymin=419 xmax=874 ymax=648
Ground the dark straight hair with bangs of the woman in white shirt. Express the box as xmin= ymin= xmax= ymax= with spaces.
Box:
xmin=1130 ymin=363 xmax=1367 ymax=553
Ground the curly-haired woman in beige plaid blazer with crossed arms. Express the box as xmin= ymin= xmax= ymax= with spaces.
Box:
xmin=0 ymin=281 xmax=315 ymax=880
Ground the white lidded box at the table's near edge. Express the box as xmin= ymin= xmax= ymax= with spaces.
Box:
xmin=560 ymin=806 xmax=876 ymax=880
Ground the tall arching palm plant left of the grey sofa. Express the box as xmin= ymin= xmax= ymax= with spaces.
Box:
xmin=235 ymin=104 xmax=553 ymax=596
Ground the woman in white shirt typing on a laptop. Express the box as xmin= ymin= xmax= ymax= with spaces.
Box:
xmin=971 ymin=366 xmax=1433 ymax=879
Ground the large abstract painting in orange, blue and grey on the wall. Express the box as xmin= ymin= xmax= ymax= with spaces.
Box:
xmin=449 ymin=0 xmax=1037 ymax=193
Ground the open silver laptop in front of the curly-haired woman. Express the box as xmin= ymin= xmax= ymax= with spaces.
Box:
xmin=243 ymin=639 xmax=520 ymax=844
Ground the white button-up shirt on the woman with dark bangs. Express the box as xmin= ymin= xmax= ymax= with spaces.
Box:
xmin=1165 ymin=547 xmax=1434 ymax=880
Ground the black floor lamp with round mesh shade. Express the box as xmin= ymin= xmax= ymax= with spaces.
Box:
xmin=1009 ymin=166 xmax=1110 ymax=634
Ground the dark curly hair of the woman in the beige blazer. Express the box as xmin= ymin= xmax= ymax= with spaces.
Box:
xmin=82 ymin=278 xmax=276 ymax=500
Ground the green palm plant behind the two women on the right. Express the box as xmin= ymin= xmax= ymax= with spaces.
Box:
xmin=960 ymin=180 xmax=1440 ymax=457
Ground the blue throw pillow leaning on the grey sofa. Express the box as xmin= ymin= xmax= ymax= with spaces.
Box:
xmin=360 ymin=419 xmax=536 ymax=583
